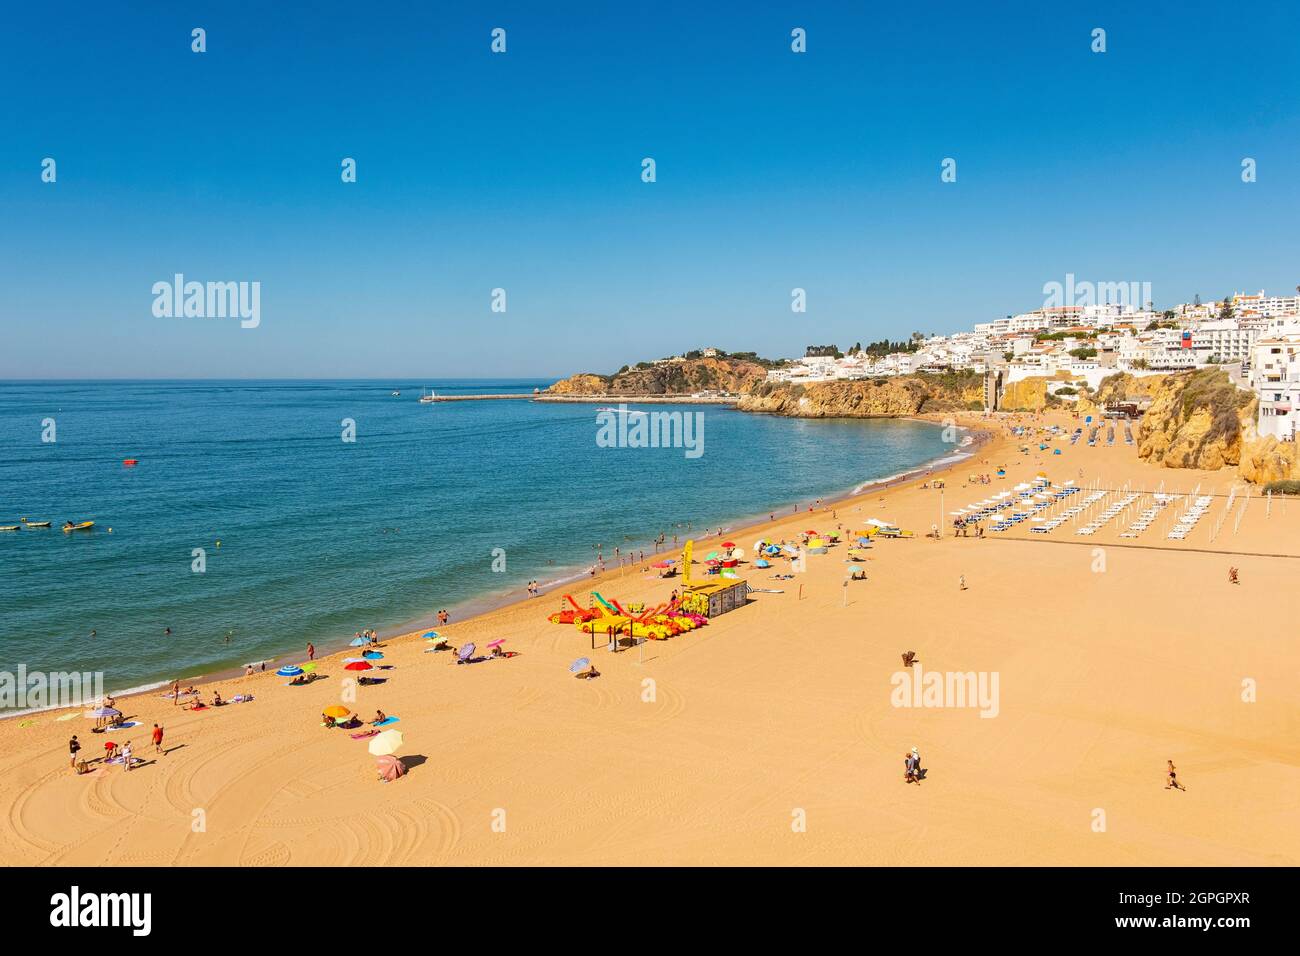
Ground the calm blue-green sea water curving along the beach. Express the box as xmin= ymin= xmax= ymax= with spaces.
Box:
xmin=0 ymin=380 xmax=952 ymax=691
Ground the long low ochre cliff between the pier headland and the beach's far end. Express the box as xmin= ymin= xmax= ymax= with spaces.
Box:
xmin=737 ymin=376 xmax=984 ymax=419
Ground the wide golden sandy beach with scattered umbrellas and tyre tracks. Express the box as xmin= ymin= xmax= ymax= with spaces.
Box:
xmin=0 ymin=415 xmax=1300 ymax=866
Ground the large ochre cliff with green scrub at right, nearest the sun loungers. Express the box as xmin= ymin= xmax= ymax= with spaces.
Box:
xmin=1133 ymin=368 xmax=1256 ymax=471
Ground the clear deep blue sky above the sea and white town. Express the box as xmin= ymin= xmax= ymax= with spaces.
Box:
xmin=0 ymin=3 xmax=1300 ymax=378
